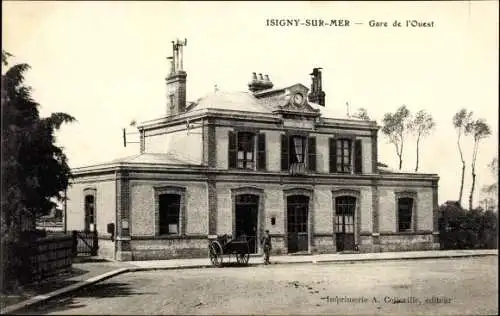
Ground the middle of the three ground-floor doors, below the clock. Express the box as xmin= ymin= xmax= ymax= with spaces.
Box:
xmin=287 ymin=195 xmax=309 ymax=253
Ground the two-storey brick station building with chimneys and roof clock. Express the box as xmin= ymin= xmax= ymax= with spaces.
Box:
xmin=67 ymin=42 xmax=439 ymax=260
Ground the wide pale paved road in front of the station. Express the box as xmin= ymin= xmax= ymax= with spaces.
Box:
xmin=17 ymin=256 xmax=498 ymax=315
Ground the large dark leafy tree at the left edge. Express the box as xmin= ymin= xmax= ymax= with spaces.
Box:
xmin=1 ymin=51 xmax=75 ymax=242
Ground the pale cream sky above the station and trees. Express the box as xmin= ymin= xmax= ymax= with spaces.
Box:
xmin=2 ymin=1 xmax=499 ymax=203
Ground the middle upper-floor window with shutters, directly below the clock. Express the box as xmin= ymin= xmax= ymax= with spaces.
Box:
xmin=281 ymin=135 xmax=316 ymax=173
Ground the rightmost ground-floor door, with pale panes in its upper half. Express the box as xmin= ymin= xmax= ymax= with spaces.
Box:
xmin=335 ymin=196 xmax=356 ymax=251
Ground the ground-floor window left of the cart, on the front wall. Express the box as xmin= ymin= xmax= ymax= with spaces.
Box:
xmin=159 ymin=194 xmax=181 ymax=235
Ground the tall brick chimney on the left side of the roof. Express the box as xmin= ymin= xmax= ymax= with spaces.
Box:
xmin=166 ymin=40 xmax=187 ymax=116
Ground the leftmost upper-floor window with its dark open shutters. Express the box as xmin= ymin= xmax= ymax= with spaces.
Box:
xmin=228 ymin=132 xmax=266 ymax=170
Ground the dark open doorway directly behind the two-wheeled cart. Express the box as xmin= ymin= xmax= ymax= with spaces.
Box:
xmin=234 ymin=194 xmax=259 ymax=253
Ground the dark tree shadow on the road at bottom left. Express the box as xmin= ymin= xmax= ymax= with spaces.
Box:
xmin=15 ymin=282 xmax=155 ymax=315
